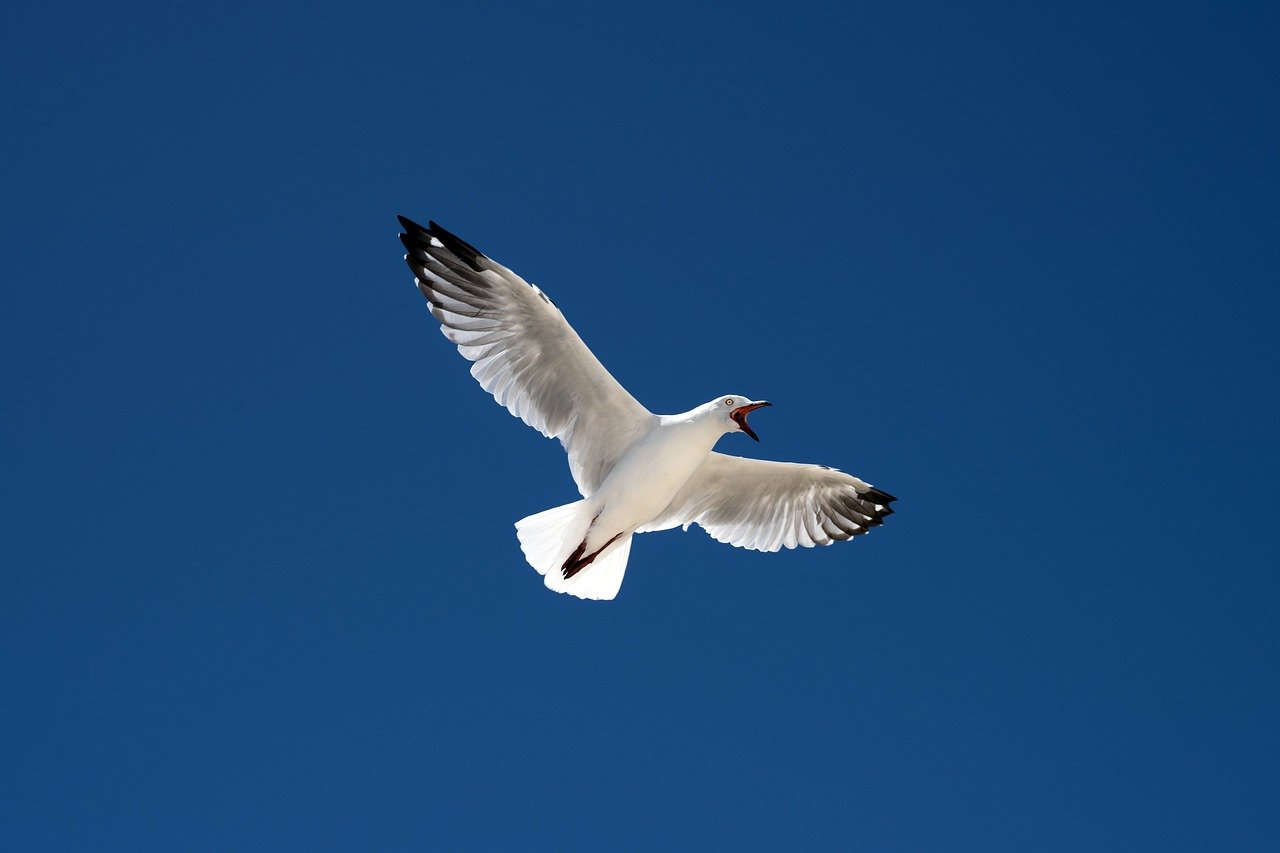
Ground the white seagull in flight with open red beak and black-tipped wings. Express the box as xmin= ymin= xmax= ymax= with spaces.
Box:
xmin=398 ymin=216 xmax=896 ymax=601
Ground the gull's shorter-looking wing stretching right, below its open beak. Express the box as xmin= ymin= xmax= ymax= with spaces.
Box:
xmin=640 ymin=452 xmax=897 ymax=551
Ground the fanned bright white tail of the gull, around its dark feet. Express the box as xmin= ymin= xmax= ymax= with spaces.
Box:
xmin=516 ymin=501 xmax=631 ymax=601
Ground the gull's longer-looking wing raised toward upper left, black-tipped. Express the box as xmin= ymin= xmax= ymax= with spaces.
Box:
xmin=399 ymin=216 xmax=657 ymax=497
